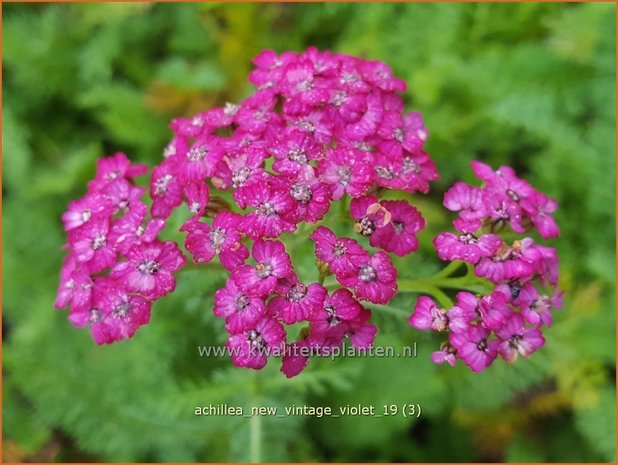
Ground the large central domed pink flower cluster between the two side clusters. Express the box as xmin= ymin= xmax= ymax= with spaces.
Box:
xmin=144 ymin=48 xmax=438 ymax=376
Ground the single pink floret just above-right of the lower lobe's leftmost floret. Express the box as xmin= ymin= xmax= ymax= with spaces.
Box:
xmin=232 ymin=239 xmax=293 ymax=297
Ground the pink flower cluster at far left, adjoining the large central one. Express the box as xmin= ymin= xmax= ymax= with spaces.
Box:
xmin=55 ymin=153 xmax=185 ymax=344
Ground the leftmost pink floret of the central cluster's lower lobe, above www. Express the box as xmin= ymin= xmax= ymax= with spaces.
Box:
xmin=213 ymin=279 xmax=266 ymax=334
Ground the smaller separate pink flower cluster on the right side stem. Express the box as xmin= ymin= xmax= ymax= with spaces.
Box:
xmin=409 ymin=162 xmax=562 ymax=371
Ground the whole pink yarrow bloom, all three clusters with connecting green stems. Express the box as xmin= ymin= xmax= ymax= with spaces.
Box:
xmin=55 ymin=48 xmax=561 ymax=377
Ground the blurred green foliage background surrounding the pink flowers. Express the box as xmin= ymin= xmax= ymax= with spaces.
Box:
xmin=2 ymin=3 xmax=615 ymax=462
